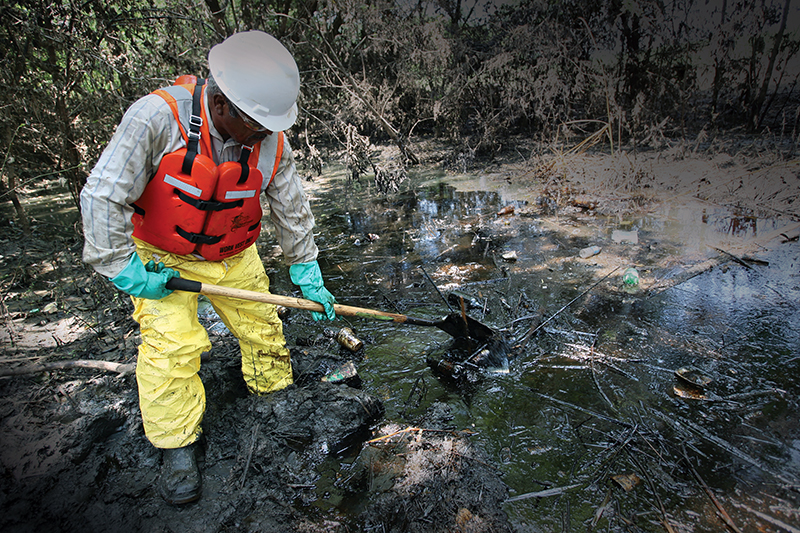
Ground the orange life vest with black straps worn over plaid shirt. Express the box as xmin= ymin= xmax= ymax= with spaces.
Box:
xmin=133 ymin=76 xmax=283 ymax=261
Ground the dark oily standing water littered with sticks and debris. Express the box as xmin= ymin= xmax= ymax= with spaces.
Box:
xmin=262 ymin=164 xmax=800 ymax=532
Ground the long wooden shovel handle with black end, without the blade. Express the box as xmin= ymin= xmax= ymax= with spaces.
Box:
xmin=166 ymin=278 xmax=414 ymax=323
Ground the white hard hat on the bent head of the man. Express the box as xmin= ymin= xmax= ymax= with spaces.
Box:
xmin=208 ymin=31 xmax=300 ymax=131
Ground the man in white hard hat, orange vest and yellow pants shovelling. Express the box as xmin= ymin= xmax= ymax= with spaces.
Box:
xmin=81 ymin=31 xmax=335 ymax=505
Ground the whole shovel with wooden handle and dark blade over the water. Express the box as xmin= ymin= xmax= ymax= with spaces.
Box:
xmin=166 ymin=278 xmax=494 ymax=341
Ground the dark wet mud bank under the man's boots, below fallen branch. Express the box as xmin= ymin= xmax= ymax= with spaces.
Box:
xmin=0 ymin=337 xmax=509 ymax=533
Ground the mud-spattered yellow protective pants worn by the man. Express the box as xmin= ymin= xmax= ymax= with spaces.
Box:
xmin=133 ymin=239 xmax=292 ymax=448
